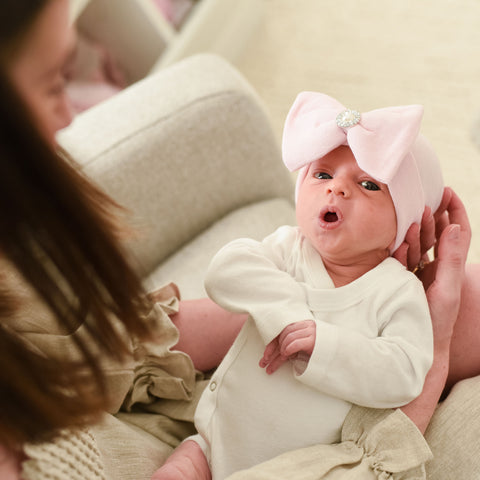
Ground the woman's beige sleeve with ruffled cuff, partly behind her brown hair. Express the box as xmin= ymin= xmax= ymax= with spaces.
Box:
xmin=0 ymin=253 xmax=199 ymax=413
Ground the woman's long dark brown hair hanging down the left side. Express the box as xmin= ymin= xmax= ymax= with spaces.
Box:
xmin=0 ymin=0 xmax=151 ymax=448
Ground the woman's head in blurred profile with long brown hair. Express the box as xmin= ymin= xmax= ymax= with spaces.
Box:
xmin=0 ymin=1 xmax=156 ymax=472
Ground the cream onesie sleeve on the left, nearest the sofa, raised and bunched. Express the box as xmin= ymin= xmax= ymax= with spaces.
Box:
xmin=205 ymin=227 xmax=313 ymax=344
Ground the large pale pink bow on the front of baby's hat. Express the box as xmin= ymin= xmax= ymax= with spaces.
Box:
xmin=282 ymin=92 xmax=423 ymax=184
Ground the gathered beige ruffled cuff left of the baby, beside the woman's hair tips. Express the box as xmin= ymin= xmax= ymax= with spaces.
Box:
xmin=116 ymin=284 xmax=208 ymax=448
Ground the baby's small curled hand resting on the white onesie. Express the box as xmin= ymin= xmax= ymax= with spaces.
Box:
xmin=259 ymin=320 xmax=316 ymax=375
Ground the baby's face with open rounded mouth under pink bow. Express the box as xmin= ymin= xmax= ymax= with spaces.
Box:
xmin=296 ymin=146 xmax=397 ymax=267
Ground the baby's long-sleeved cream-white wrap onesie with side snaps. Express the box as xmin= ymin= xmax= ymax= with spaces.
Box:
xmin=191 ymin=226 xmax=433 ymax=480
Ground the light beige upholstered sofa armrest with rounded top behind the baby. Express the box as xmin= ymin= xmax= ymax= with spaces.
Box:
xmin=58 ymin=54 xmax=293 ymax=274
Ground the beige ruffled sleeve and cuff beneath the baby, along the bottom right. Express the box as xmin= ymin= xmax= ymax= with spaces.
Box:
xmin=228 ymin=406 xmax=432 ymax=480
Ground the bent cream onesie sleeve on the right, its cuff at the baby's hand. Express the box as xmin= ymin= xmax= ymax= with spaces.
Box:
xmin=296 ymin=278 xmax=433 ymax=408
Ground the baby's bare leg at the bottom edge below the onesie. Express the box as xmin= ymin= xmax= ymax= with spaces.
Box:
xmin=151 ymin=440 xmax=212 ymax=480
